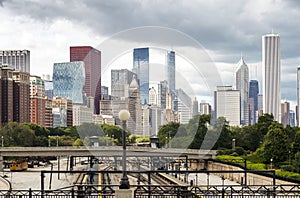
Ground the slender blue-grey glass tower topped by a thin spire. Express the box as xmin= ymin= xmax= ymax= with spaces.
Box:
xmin=167 ymin=51 xmax=175 ymax=94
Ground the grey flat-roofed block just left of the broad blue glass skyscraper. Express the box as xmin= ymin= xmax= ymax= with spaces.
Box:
xmin=111 ymin=69 xmax=134 ymax=98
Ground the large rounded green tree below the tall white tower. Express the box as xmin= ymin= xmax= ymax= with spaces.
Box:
xmin=259 ymin=122 xmax=289 ymax=164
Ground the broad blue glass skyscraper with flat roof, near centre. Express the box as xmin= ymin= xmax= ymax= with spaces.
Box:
xmin=132 ymin=48 xmax=149 ymax=104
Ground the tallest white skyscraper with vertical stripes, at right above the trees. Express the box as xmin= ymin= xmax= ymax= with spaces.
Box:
xmin=262 ymin=33 xmax=281 ymax=121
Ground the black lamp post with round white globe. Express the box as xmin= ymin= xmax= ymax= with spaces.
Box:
xmin=119 ymin=109 xmax=130 ymax=189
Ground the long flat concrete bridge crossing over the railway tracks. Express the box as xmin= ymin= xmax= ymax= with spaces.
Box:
xmin=0 ymin=146 xmax=216 ymax=159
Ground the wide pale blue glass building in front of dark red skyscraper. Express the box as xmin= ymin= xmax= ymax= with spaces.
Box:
xmin=53 ymin=61 xmax=85 ymax=104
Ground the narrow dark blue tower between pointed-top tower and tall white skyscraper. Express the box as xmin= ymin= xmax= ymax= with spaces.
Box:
xmin=249 ymin=80 xmax=259 ymax=124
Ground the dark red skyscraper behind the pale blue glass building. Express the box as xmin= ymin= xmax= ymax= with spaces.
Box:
xmin=70 ymin=46 xmax=101 ymax=114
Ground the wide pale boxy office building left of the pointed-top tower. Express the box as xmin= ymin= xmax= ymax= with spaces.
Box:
xmin=214 ymin=86 xmax=241 ymax=126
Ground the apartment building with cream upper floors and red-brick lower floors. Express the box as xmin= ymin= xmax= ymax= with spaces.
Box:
xmin=30 ymin=76 xmax=46 ymax=125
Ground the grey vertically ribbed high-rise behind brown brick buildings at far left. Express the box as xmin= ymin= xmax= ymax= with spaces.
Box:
xmin=0 ymin=50 xmax=30 ymax=73
